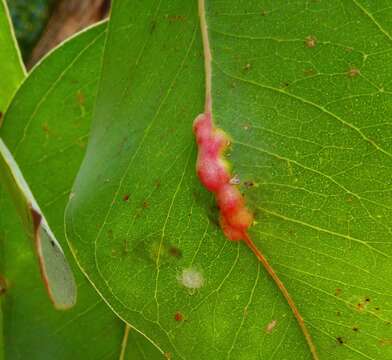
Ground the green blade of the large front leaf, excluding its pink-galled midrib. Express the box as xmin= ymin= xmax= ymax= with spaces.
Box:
xmin=66 ymin=0 xmax=392 ymax=360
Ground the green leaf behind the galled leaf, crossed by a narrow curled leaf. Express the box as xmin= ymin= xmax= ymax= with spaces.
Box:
xmin=0 ymin=24 xmax=162 ymax=360
